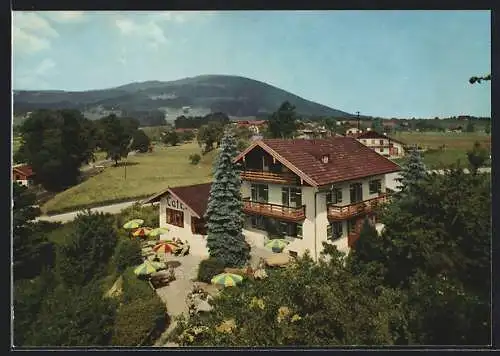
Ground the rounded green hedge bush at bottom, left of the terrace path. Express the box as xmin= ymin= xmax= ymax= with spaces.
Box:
xmin=111 ymin=267 xmax=166 ymax=346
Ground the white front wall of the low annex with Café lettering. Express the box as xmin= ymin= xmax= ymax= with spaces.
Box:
xmin=159 ymin=196 xmax=208 ymax=257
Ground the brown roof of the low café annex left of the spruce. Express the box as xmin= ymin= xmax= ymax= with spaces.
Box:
xmin=142 ymin=183 xmax=212 ymax=217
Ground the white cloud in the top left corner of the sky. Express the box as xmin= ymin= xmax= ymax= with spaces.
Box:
xmin=12 ymin=12 xmax=59 ymax=54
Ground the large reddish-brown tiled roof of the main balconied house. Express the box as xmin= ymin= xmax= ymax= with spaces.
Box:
xmin=235 ymin=137 xmax=401 ymax=186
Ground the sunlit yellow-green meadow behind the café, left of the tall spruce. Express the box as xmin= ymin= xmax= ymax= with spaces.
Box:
xmin=42 ymin=143 xmax=215 ymax=213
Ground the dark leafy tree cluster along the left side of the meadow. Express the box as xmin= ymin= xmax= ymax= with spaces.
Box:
xmin=14 ymin=110 xmax=150 ymax=192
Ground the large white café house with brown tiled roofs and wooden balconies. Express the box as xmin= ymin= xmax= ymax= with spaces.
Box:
xmin=143 ymin=137 xmax=400 ymax=259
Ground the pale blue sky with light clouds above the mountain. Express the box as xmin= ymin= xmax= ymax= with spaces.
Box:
xmin=12 ymin=10 xmax=491 ymax=118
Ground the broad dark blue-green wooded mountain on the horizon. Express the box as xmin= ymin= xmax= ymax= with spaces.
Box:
xmin=14 ymin=75 xmax=352 ymax=120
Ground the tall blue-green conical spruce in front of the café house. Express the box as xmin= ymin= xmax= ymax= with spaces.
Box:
xmin=205 ymin=131 xmax=250 ymax=266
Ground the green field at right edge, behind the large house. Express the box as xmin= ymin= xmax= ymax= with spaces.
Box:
xmin=392 ymin=132 xmax=491 ymax=169
